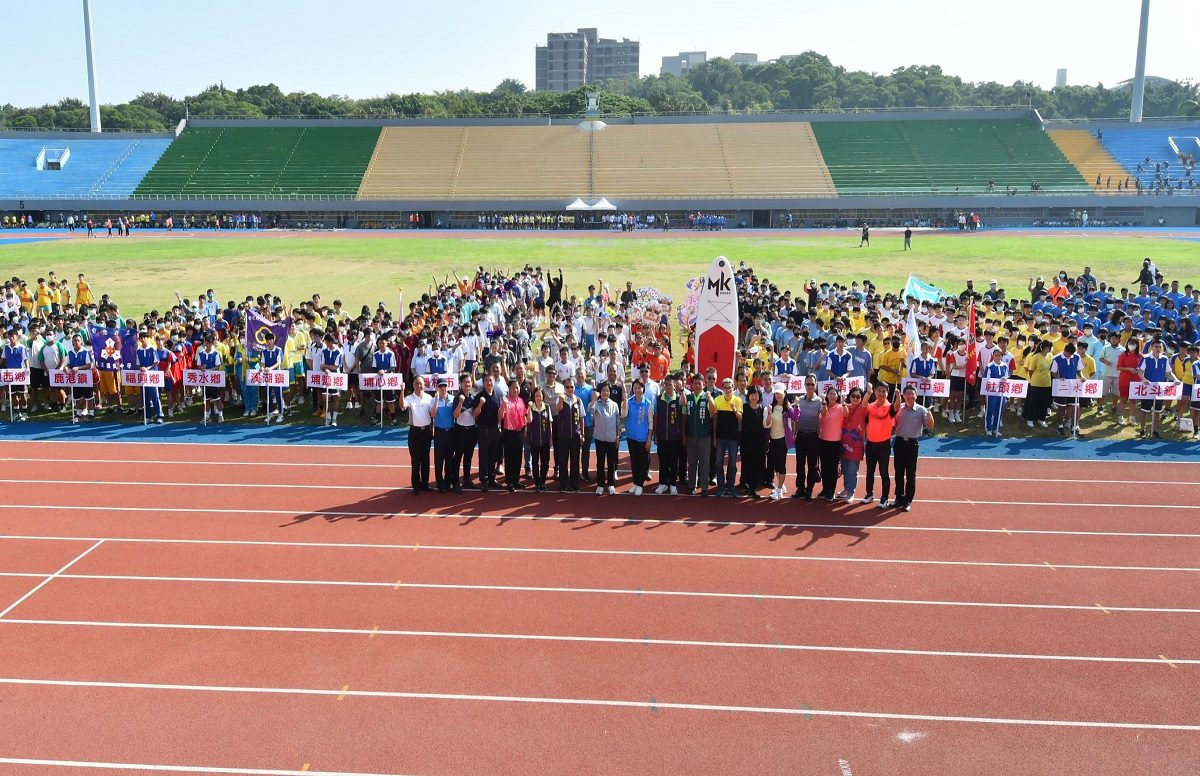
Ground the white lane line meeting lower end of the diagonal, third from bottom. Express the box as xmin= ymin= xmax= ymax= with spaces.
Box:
xmin=0 ymin=619 xmax=1200 ymax=666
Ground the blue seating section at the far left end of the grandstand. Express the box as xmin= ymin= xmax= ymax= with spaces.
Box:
xmin=0 ymin=136 xmax=170 ymax=198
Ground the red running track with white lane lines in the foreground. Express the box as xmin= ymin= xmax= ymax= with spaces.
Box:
xmin=0 ymin=443 xmax=1200 ymax=775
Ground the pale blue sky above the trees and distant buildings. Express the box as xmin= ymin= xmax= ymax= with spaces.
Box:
xmin=0 ymin=0 xmax=1200 ymax=106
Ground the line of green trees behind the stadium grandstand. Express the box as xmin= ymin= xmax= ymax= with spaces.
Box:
xmin=0 ymin=52 xmax=1200 ymax=131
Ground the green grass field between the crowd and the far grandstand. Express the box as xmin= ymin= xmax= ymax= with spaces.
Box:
xmin=9 ymin=231 xmax=1200 ymax=315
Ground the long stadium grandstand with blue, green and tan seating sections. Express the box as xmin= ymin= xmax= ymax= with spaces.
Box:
xmin=0 ymin=109 xmax=1200 ymax=227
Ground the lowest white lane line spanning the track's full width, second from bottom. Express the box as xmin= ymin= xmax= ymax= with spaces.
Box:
xmin=0 ymin=676 xmax=1200 ymax=733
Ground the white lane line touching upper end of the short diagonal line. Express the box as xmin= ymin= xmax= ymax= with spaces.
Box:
xmin=0 ymin=530 xmax=1200 ymax=573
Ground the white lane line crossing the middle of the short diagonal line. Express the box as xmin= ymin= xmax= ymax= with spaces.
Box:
xmin=0 ymin=572 xmax=1200 ymax=614
